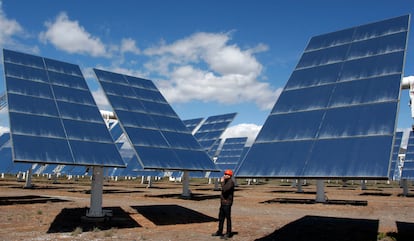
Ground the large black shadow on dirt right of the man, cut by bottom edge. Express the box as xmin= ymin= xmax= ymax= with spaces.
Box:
xmin=256 ymin=216 xmax=379 ymax=241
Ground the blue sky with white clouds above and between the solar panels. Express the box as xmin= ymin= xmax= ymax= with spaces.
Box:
xmin=0 ymin=0 xmax=414 ymax=145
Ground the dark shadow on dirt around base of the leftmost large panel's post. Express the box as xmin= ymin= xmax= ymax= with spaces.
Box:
xmin=47 ymin=207 xmax=141 ymax=233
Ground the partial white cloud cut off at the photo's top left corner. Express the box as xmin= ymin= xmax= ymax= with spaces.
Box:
xmin=0 ymin=1 xmax=24 ymax=46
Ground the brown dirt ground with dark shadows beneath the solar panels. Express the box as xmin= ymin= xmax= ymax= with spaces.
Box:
xmin=0 ymin=175 xmax=414 ymax=241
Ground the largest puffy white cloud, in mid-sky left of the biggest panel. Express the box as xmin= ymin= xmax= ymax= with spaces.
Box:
xmin=144 ymin=33 xmax=281 ymax=109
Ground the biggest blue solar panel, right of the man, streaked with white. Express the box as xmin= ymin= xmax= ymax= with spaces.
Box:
xmin=236 ymin=15 xmax=410 ymax=179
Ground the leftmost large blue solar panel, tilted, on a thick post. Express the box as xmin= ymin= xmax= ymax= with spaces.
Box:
xmin=3 ymin=49 xmax=125 ymax=166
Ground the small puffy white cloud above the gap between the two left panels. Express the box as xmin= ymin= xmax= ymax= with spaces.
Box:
xmin=39 ymin=12 xmax=109 ymax=57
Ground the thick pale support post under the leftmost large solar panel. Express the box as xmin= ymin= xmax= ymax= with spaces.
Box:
xmin=86 ymin=166 xmax=105 ymax=218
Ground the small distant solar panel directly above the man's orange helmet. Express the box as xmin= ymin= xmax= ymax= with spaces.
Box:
xmin=209 ymin=137 xmax=247 ymax=177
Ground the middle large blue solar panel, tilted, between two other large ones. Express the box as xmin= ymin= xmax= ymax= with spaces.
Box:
xmin=94 ymin=69 xmax=216 ymax=171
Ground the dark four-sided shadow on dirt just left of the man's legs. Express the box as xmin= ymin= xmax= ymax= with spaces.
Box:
xmin=132 ymin=205 xmax=217 ymax=225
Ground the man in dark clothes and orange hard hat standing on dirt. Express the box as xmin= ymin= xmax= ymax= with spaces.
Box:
xmin=213 ymin=170 xmax=234 ymax=239
